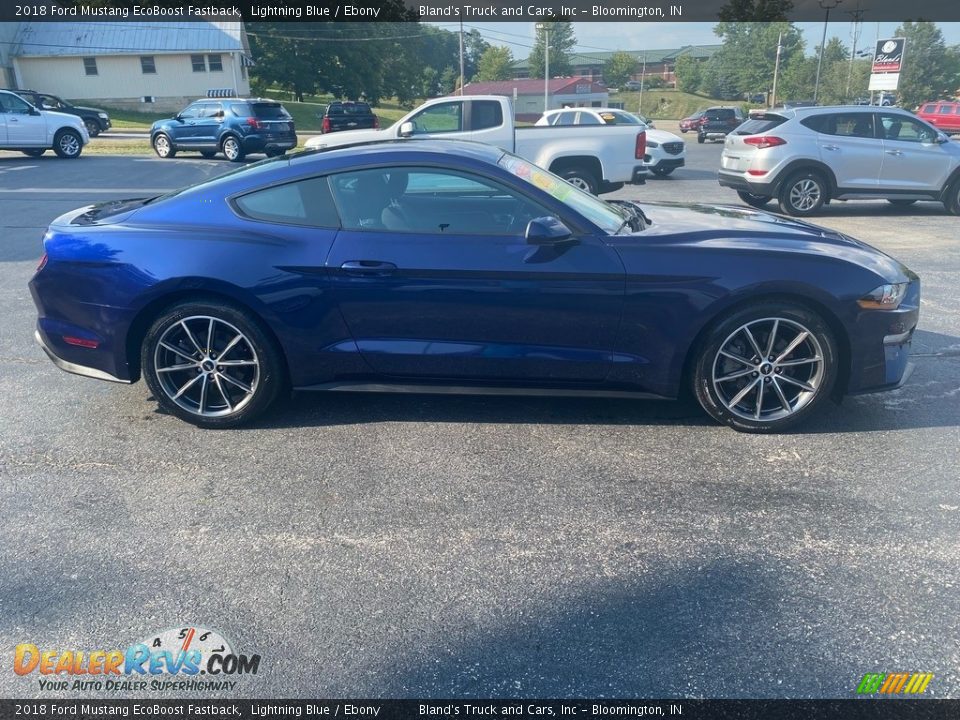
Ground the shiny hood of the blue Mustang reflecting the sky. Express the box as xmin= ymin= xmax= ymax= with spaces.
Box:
xmin=611 ymin=203 xmax=916 ymax=282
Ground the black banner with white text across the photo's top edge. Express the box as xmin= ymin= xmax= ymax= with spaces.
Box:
xmin=0 ymin=0 xmax=960 ymax=23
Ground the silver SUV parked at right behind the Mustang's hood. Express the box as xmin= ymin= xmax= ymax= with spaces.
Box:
xmin=718 ymin=106 xmax=960 ymax=216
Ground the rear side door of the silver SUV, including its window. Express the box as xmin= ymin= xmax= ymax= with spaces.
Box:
xmin=817 ymin=112 xmax=883 ymax=192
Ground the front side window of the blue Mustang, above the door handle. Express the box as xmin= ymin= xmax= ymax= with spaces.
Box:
xmin=330 ymin=167 xmax=551 ymax=237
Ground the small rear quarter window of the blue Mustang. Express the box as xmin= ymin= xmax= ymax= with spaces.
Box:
xmin=234 ymin=177 xmax=340 ymax=228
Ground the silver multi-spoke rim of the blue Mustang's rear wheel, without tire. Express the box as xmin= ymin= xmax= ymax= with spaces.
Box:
xmin=153 ymin=315 xmax=260 ymax=417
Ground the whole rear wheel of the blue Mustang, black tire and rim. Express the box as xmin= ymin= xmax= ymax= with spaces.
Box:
xmin=140 ymin=300 xmax=285 ymax=428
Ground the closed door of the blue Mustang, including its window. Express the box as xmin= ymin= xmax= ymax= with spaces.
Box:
xmin=327 ymin=167 xmax=625 ymax=383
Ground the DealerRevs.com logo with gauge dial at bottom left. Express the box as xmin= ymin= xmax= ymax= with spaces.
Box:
xmin=13 ymin=627 xmax=260 ymax=691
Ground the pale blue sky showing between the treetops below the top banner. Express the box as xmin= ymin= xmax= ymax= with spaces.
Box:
xmin=430 ymin=21 xmax=960 ymax=59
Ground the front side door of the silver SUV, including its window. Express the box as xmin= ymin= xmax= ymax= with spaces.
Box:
xmin=878 ymin=112 xmax=952 ymax=192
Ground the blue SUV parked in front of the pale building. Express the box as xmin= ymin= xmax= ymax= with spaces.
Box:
xmin=150 ymin=98 xmax=297 ymax=162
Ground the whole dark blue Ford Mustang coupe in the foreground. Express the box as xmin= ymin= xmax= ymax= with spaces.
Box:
xmin=30 ymin=140 xmax=920 ymax=432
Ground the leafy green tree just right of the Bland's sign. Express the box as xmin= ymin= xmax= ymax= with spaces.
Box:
xmin=894 ymin=21 xmax=960 ymax=108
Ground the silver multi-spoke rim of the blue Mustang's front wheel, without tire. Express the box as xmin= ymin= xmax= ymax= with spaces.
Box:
xmin=711 ymin=317 xmax=824 ymax=422
